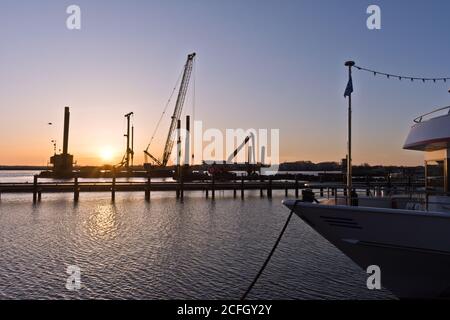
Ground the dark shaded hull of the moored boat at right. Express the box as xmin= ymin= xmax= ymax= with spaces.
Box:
xmin=284 ymin=200 xmax=450 ymax=298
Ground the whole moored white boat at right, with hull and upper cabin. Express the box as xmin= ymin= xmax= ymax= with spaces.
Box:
xmin=283 ymin=107 xmax=450 ymax=298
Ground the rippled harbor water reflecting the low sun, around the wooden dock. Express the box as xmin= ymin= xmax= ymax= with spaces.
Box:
xmin=0 ymin=171 xmax=394 ymax=299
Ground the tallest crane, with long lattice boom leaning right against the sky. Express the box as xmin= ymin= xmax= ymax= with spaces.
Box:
xmin=144 ymin=52 xmax=196 ymax=167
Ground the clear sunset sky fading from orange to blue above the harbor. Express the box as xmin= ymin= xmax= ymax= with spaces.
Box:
xmin=0 ymin=0 xmax=450 ymax=165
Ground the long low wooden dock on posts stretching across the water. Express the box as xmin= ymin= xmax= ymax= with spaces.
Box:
xmin=0 ymin=176 xmax=422 ymax=203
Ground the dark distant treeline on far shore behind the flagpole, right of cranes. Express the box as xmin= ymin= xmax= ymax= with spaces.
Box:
xmin=279 ymin=161 xmax=424 ymax=175
